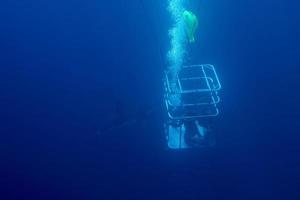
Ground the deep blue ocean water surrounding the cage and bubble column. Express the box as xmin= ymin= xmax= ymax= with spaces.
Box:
xmin=0 ymin=0 xmax=300 ymax=200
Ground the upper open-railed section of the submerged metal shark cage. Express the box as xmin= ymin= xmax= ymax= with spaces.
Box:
xmin=164 ymin=64 xmax=221 ymax=120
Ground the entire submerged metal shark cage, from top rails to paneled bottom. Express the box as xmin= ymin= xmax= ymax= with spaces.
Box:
xmin=163 ymin=64 xmax=221 ymax=149
